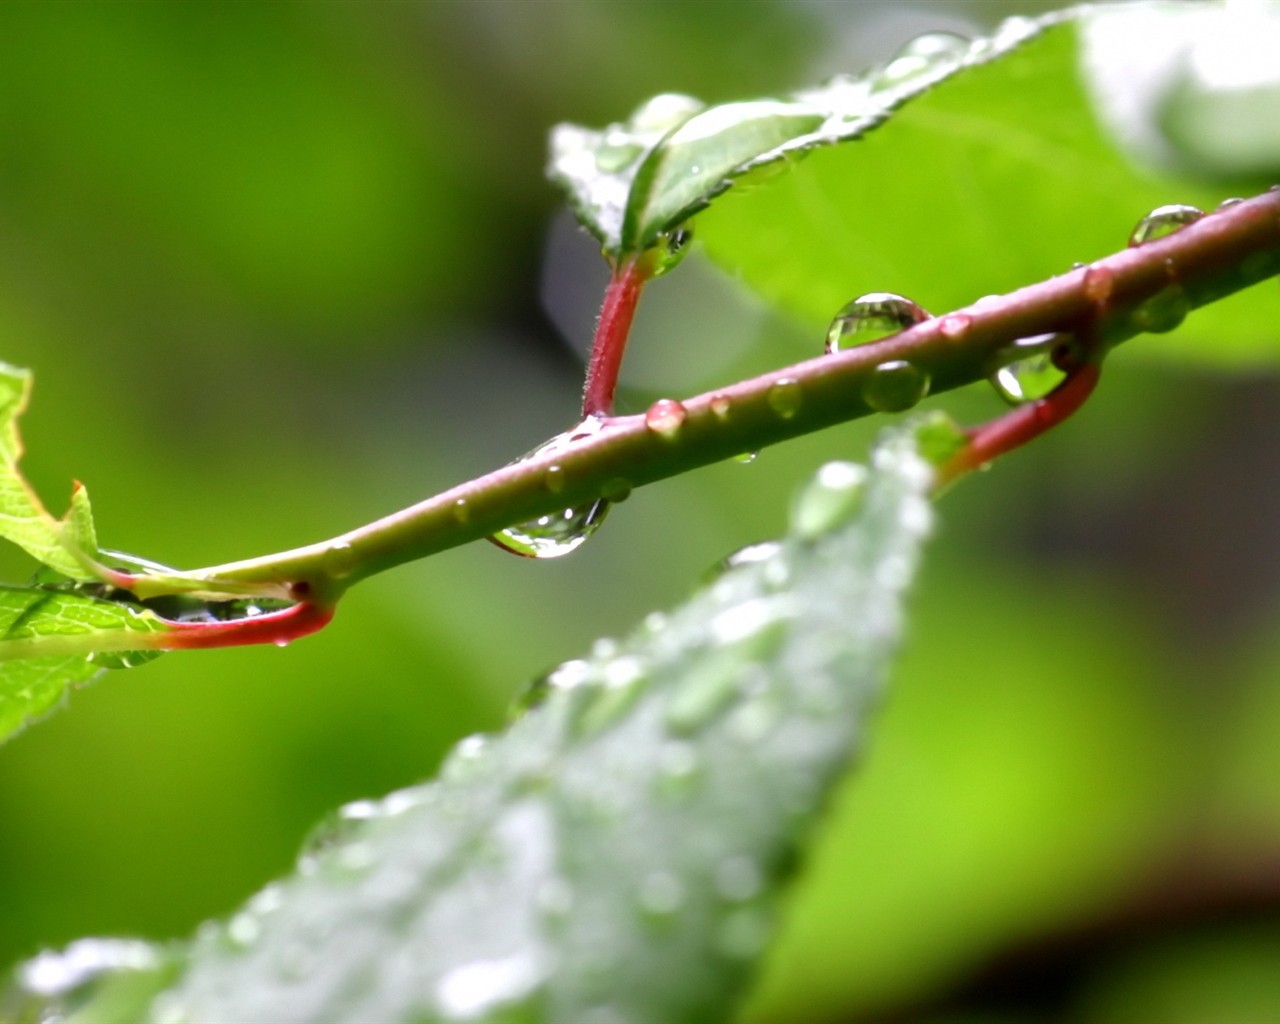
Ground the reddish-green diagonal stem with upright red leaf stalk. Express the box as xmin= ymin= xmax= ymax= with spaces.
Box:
xmin=165 ymin=192 xmax=1280 ymax=605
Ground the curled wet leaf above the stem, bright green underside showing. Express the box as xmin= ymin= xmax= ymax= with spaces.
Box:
xmin=553 ymin=3 xmax=1280 ymax=364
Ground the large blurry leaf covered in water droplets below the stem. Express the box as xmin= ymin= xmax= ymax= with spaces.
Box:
xmin=12 ymin=419 xmax=932 ymax=1024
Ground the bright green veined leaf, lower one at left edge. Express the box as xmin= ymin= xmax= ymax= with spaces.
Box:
xmin=0 ymin=586 xmax=169 ymax=742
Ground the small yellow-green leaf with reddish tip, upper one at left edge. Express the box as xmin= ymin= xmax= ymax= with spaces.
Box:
xmin=0 ymin=362 xmax=97 ymax=580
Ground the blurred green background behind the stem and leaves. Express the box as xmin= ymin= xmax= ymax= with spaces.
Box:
xmin=0 ymin=0 xmax=1280 ymax=1024
